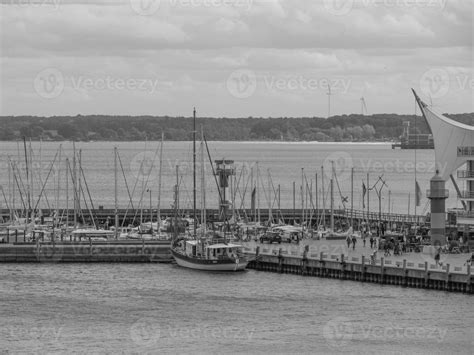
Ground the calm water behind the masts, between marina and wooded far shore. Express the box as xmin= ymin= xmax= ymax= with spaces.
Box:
xmin=0 ymin=142 xmax=463 ymax=214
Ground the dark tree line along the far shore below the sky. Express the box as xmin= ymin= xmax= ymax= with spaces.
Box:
xmin=0 ymin=113 xmax=474 ymax=142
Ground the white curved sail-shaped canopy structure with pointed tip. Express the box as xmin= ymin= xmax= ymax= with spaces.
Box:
xmin=413 ymin=91 xmax=474 ymax=181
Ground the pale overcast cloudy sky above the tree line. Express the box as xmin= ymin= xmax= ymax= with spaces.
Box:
xmin=0 ymin=0 xmax=474 ymax=117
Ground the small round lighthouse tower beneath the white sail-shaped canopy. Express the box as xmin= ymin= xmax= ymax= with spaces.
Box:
xmin=426 ymin=170 xmax=449 ymax=246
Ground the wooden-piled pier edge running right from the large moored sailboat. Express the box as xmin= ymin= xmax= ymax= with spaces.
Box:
xmin=245 ymin=245 xmax=474 ymax=294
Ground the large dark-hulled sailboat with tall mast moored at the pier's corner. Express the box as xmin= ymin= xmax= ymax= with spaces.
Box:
xmin=171 ymin=109 xmax=248 ymax=271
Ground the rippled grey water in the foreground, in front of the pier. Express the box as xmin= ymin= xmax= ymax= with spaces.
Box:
xmin=0 ymin=264 xmax=474 ymax=354
